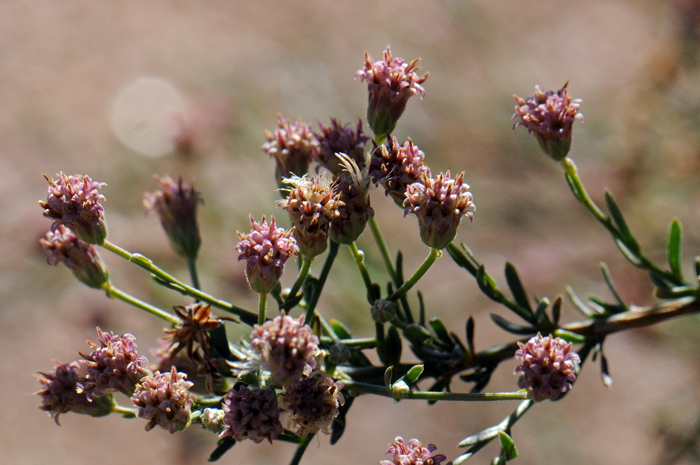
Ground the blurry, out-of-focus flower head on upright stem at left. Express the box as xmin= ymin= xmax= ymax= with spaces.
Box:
xmin=143 ymin=176 xmax=204 ymax=260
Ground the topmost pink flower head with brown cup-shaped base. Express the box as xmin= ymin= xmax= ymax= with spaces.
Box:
xmin=355 ymin=46 xmax=429 ymax=138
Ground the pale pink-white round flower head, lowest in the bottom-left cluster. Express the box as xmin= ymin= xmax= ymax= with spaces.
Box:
xmin=131 ymin=367 xmax=195 ymax=434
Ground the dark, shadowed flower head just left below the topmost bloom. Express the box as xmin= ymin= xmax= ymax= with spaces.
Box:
xmin=314 ymin=118 xmax=367 ymax=174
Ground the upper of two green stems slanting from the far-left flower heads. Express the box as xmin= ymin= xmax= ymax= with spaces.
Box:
xmin=102 ymin=241 xmax=258 ymax=326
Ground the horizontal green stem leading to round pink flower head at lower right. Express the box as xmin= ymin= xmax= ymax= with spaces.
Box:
xmin=341 ymin=379 xmax=527 ymax=402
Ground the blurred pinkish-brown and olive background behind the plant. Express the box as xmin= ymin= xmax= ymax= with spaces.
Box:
xmin=0 ymin=0 xmax=700 ymax=465
